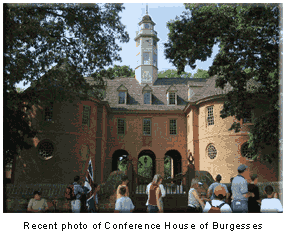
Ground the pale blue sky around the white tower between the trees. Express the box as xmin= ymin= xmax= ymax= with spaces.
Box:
xmin=17 ymin=3 xmax=219 ymax=89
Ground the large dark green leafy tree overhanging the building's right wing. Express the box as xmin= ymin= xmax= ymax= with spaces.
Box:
xmin=164 ymin=4 xmax=282 ymax=162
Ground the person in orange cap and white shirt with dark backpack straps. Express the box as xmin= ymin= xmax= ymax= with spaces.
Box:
xmin=203 ymin=184 xmax=232 ymax=213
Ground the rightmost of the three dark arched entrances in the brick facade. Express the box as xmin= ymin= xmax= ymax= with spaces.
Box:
xmin=164 ymin=149 xmax=182 ymax=178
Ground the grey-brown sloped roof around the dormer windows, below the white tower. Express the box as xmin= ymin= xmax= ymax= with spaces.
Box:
xmin=84 ymin=76 xmax=259 ymax=111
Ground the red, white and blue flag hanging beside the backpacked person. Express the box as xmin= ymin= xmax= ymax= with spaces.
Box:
xmin=84 ymin=158 xmax=96 ymax=211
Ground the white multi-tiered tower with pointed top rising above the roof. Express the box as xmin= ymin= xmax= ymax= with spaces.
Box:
xmin=134 ymin=10 xmax=159 ymax=85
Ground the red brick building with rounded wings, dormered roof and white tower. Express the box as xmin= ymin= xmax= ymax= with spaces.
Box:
xmin=12 ymin=11 xmax=278 ymax=184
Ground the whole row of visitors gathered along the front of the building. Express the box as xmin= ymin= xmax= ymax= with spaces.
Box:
xmin=27 ymin=164 xmax=283 ymax=213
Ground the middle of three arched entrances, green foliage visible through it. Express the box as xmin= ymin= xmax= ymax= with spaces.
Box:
xmin=138 ymin=150 xmax=156 ymax=178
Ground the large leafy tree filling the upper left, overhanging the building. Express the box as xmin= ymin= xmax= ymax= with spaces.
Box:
xmin=3 ymin=4 xmax=129 ymax=166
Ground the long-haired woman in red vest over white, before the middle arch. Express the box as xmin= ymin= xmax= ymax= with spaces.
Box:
xmin=146 ymin=174 xmax=165 ymax=213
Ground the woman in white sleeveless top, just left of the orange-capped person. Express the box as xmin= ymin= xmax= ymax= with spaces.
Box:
xmin=187 ymin=178 xmax=205 ymax=213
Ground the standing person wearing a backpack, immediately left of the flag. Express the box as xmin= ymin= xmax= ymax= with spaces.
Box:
xmin=65 ymin=175 xmax=84 ymax=213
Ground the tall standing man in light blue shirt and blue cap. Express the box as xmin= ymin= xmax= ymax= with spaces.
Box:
xmin=231 ymin=164 xmax=254 ymax=213
